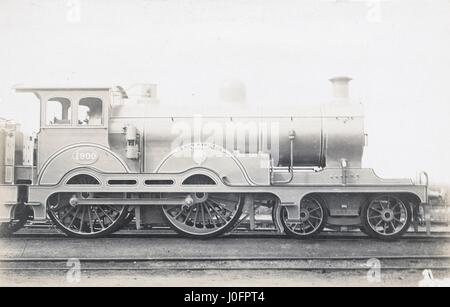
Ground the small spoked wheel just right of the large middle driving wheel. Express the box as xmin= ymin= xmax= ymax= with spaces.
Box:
xmin=281 ymin=196 xmax=328 ymax=238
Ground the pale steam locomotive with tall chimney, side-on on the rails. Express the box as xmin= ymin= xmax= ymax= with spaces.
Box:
xmin=0 ymin=77 xmax=428 ymax=239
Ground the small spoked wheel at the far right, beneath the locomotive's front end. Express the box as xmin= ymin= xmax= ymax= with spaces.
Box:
xmin=361 ymin=195 xmax=412 ymax=240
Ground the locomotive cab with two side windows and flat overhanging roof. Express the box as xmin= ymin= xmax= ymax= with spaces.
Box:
xmin=16 ymin=87 xmax=115 ymax=178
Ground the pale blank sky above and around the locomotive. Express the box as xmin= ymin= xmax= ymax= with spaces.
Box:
xmin=0 ymin=0 xmax=450 ymax=183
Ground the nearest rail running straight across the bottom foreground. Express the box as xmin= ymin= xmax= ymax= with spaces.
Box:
xmin=0 ymin=255 xmax=450 ymax=272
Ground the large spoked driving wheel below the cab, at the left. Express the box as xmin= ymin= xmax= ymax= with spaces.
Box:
xmin=48 ymin=193 xmax=128 ymax=238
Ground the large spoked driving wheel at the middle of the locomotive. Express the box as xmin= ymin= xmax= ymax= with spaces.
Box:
xmin=162 ymin=193 xmax=244 ymax=238
